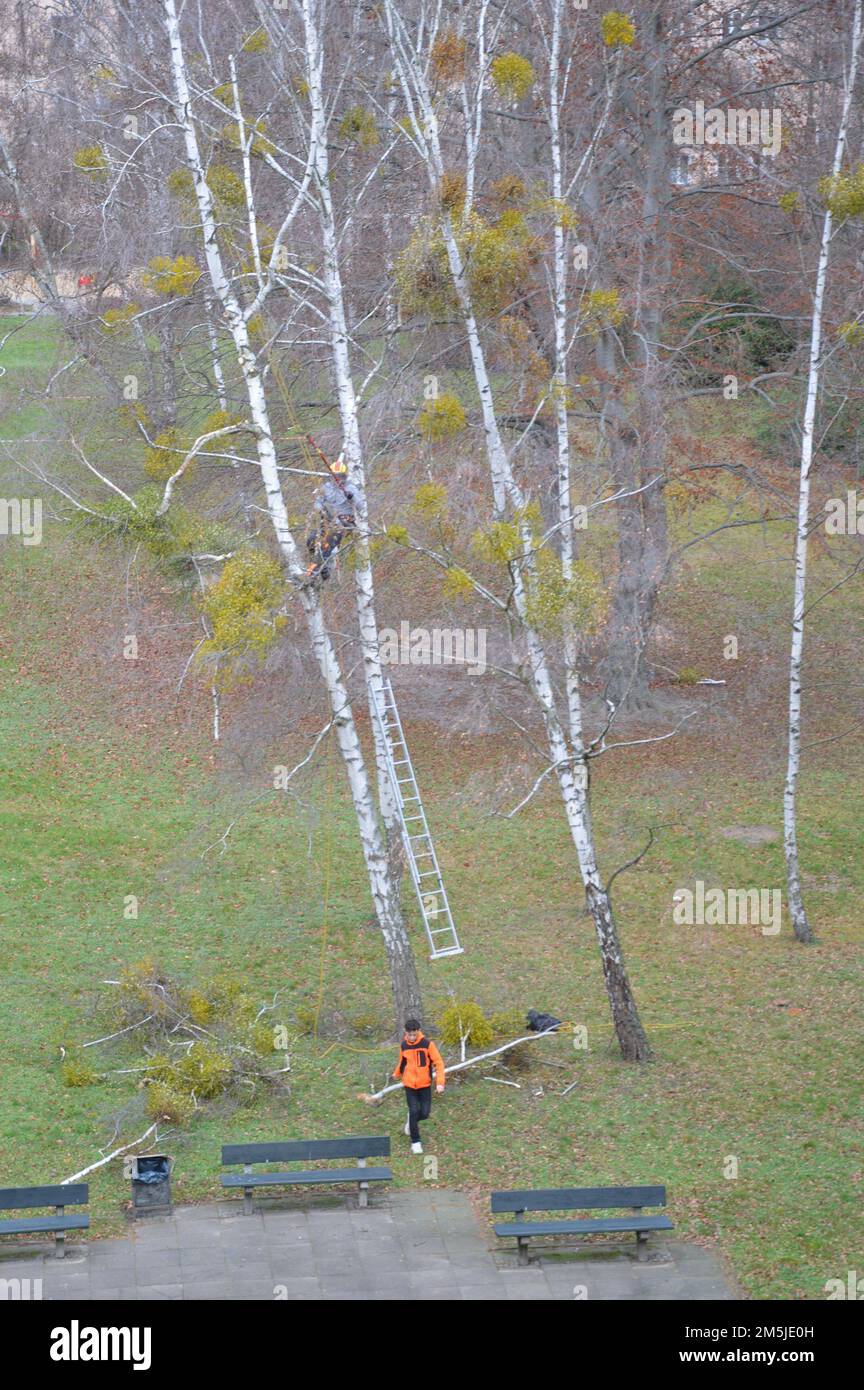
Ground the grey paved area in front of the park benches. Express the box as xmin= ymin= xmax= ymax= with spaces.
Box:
xmin=0 ymin=1188 xmax=735 ymax=1302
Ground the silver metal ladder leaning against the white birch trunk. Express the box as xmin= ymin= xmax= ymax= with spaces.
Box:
xmin=374 ymin=680 xmax=463 ymax=960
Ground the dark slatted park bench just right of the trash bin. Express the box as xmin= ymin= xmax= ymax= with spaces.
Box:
xmin=222 ymin=1134 xmax=393 ymax=1212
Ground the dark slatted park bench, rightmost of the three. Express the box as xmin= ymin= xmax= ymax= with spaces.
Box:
xmin=492 ymin=1187 xmax=675 ymax=1265
